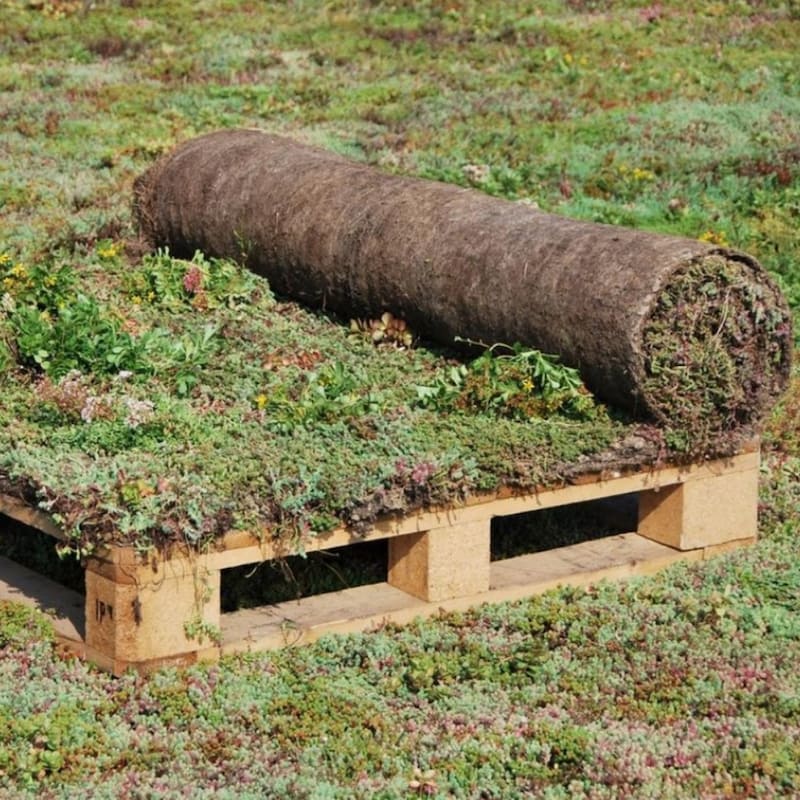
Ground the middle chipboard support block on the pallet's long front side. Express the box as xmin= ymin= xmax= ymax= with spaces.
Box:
xmin=388 ymin=519 xmax=491 ymax=601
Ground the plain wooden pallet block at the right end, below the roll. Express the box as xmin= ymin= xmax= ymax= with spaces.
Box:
xmin=638 ymin=453 xmax=759 ymax=550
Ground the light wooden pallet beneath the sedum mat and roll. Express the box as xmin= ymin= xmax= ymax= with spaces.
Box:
xmin=0 ymin=448 xmax=759 ymax=675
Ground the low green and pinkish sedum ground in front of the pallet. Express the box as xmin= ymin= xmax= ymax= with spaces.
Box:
xmin=0 ymin=510 xmax=800 ymax=800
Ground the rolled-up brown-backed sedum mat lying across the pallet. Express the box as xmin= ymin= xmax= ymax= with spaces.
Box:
xmin=135 ymin=130 xmax=792 ymax=438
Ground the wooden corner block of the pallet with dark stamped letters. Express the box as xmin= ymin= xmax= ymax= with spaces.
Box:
xmin=86 ymin=558 xmax=220 ymax=675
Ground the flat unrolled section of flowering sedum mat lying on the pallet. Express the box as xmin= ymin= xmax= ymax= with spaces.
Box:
xmin=0 ymin=242 xmax=636 ymax=551
